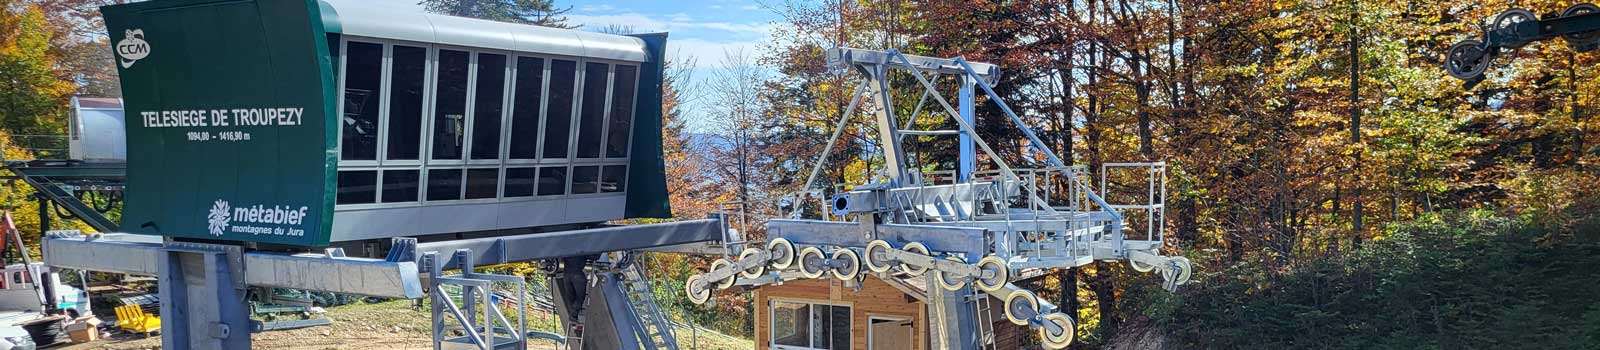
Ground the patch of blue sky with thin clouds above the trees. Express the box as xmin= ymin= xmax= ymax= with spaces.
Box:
xmin=368 ymin=0 xmax=779 ymax=133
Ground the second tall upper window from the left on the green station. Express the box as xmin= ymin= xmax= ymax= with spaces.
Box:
xmin=384 ymin=45 xmax=427 ymax=160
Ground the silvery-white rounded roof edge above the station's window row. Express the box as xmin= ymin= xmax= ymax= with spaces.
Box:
xmin=320 ymin=0 xmax=650 ymax=62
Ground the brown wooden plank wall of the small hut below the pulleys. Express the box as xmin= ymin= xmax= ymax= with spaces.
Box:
xmin=755 ymin=275 xmax=928 ymax=350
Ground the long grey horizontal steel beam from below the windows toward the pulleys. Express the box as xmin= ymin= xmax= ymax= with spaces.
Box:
xmin=416 ymin=219 xmax=723 ymax=268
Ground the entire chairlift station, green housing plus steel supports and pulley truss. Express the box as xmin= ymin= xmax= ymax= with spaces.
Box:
xmin=6 ymin=0 xmax=1190 ymax=350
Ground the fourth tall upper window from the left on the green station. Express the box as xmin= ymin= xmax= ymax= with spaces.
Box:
xmin=472 ymin=53 xmax=506 ymax=160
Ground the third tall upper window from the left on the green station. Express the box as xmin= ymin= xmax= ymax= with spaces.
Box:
xmin=429 ymin=50 xmax=472 ymax=159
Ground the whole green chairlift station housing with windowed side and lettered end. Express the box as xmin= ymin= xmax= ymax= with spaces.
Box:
xmin=102 ymin=0 xmax=670 ymax=248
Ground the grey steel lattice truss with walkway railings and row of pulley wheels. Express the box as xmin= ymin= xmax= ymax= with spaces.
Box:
xmin=685 ymin=48 xmax=1192 ymax=348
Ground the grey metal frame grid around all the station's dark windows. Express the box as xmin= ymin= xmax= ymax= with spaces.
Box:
xmin=334 ymin=35 xmax=645 ymax=211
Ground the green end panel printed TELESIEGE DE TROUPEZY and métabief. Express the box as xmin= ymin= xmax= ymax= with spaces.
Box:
xmin=101 ymin=0 xmax=338 ymax=246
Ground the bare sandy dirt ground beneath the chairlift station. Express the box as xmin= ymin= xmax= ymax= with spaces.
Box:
xmin=56 ymin=300 xmax=754 ymax=350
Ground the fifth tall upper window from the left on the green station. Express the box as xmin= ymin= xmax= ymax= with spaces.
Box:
xmin=510 ymin=58 xmax=544 ymax=160
